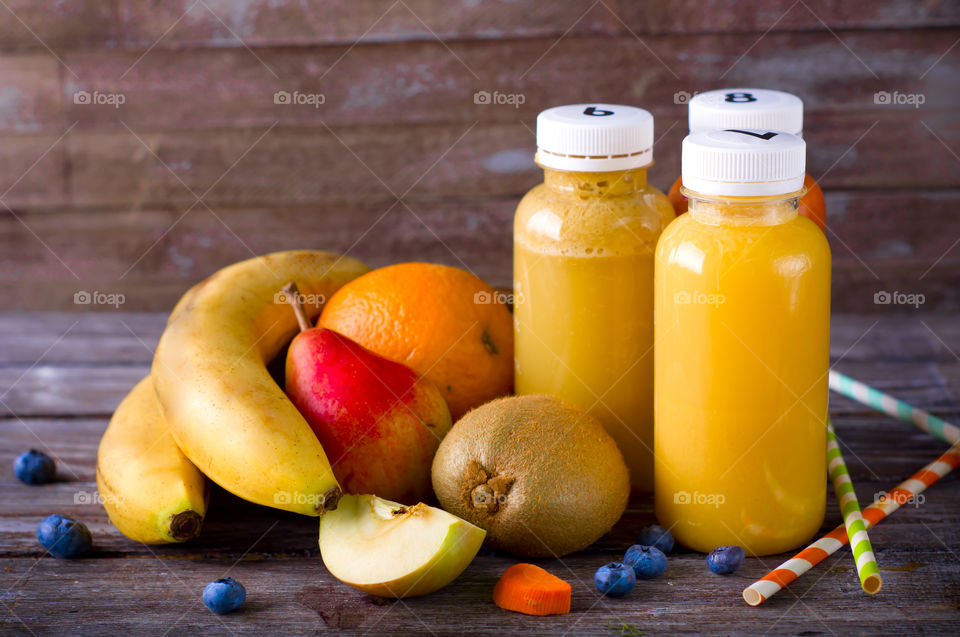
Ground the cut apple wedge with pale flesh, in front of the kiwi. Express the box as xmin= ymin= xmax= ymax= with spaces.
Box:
xmin=320 ymin=495 xmax=487 ymax=597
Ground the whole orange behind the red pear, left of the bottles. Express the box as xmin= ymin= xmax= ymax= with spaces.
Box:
xmin=317 ymin=263 xmax=513 ymax=420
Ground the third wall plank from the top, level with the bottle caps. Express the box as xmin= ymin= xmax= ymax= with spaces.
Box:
xmin=0 ymin=112 xmax=960 ymax=211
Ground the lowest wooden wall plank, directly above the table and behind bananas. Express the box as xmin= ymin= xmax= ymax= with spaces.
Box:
xmin=0 ymin=189 xmax=960 ymax=316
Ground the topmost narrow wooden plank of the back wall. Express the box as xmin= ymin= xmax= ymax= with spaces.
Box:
xmin=0 ymin=0 xmax=960 ymax=50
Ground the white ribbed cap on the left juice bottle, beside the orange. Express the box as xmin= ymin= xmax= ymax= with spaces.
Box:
xmin=537 ymin=104 xmax=653 ymax=172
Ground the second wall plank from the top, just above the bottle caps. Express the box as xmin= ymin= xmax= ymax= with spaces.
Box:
xmin=39 ymin=29 xmax=960 ymax=130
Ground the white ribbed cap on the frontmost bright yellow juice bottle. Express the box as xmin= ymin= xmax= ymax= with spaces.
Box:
xmin=681 ymin=129 xmax=807 ymax=197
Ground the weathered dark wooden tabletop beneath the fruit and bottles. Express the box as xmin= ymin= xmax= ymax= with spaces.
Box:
xmin=0 ymin=313 xmax=960 ymax=635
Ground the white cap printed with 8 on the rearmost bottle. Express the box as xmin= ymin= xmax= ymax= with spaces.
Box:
xmin=688 ymin=88 xmax=803 ymax=136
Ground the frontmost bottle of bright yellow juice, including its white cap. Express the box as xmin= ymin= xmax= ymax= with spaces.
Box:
xmin=654 ymin=130 xmax=830 ymax=555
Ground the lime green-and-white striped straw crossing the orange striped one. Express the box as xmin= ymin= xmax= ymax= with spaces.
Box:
xmin=827 ymin=418 xmax=883 ymax=595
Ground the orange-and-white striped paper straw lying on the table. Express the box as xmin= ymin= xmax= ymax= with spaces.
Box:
xmin=743 ymin=443 xmax=960 ymax=606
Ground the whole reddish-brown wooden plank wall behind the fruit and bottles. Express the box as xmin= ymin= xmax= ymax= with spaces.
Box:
xmin=0 ymin=0 xmax=960 ymax=313
